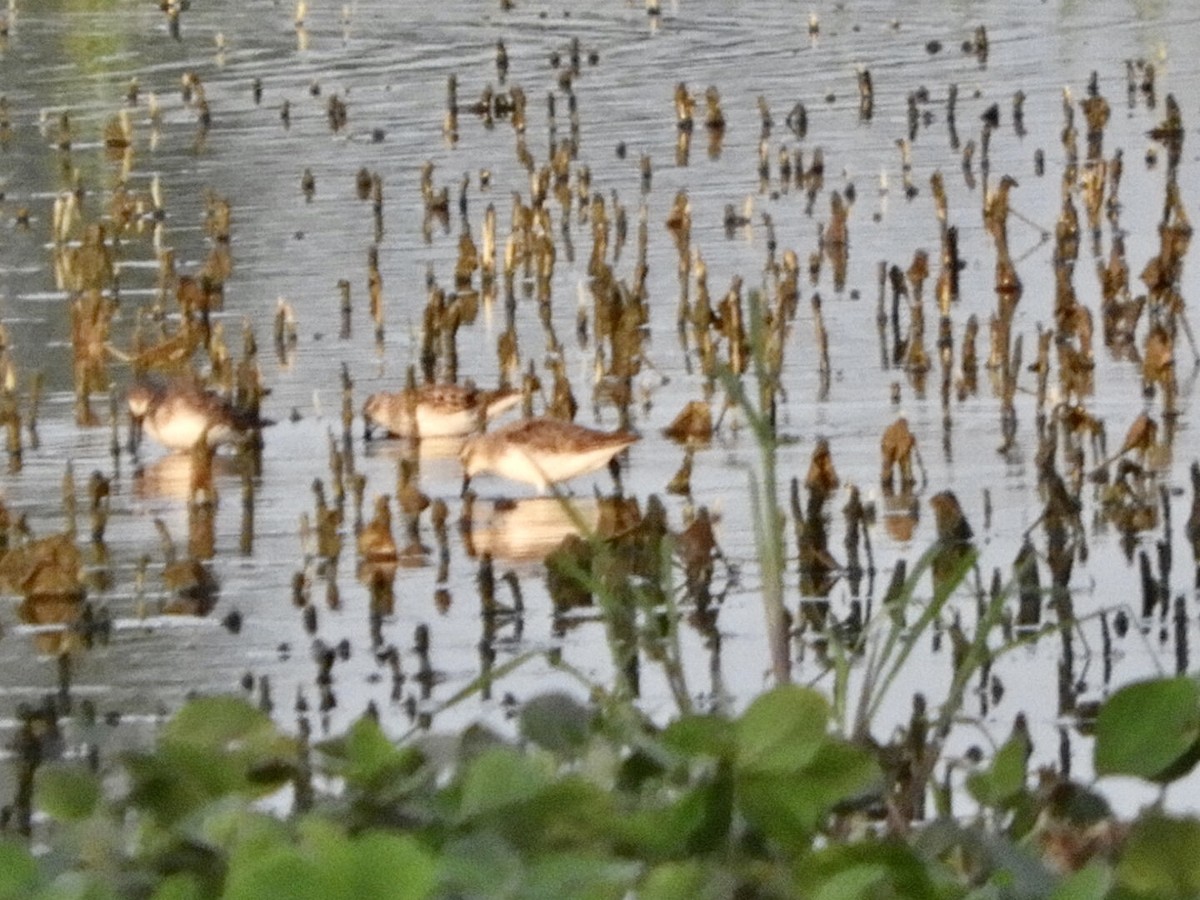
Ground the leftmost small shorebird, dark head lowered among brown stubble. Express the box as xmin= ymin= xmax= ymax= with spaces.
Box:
xmin=128 ymin=380 xmax=270 ymax=450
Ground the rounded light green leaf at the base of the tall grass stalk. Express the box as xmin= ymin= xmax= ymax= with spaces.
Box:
xmin=737 ymin=685 xmax=829 ymax=775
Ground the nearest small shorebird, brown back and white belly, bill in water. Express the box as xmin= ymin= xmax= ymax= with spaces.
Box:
xmin=460 ymin=419 xmax=638 ymax=493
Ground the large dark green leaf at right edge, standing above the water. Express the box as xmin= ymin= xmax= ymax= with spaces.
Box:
xmin=1094 ymin=677 xmax=1200 ymax=782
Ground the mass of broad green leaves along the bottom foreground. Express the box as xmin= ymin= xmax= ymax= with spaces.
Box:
xmin=7 ymin=678 xmax=1200 ymax=900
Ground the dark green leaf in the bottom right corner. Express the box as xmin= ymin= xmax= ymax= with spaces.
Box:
xmin=1117 ymin=814 xmax=1200 ymax=900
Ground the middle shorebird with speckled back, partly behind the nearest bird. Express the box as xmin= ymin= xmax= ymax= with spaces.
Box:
xmin=362 ymin=384 xmax=521 ymax=438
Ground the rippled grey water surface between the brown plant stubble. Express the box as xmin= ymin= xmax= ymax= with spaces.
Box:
xmin=0 ymin=0 xmax=1200 ymax=816
